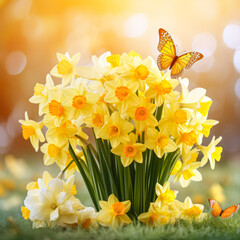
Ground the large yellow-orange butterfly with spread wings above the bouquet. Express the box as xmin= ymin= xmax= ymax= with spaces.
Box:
xmin=157 ymin=28 xmax=203 ymax=78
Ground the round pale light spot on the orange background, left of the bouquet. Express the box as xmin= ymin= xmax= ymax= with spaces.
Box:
xmin=5 ymin=51 xmax=27 ymax=75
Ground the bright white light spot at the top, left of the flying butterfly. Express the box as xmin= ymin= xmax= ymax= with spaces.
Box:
xmin=124 ymin=13 xmax=148 ymax=38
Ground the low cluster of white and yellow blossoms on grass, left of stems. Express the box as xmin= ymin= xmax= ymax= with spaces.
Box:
xmin=21 ymin=171 xmax=97 ymax=229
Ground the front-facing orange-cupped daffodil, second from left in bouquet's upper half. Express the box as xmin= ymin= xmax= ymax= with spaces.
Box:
xmin=63 ymin=79 xmax=99 ymax=119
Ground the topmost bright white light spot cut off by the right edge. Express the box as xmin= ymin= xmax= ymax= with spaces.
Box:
xmin=223 ymin=24 xmax=240 ymax=49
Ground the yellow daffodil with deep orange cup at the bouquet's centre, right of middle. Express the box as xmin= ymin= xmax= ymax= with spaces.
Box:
xmin=128 ymin=96 xmax=157 ymax=134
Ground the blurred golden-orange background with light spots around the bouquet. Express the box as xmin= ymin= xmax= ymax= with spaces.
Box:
xmin=0 ymin=0 xmax=240 ymax=225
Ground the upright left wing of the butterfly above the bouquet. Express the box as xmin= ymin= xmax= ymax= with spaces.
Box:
xmin=157 ymin=28 xmax=176 ymax=71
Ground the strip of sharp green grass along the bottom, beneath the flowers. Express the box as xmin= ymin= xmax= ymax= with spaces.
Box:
xmin=0 ymin=208 xmax=240 ymax=240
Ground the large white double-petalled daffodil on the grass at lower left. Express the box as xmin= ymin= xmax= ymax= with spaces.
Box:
xmin=24 ymin=173 xmax=84 ymax=227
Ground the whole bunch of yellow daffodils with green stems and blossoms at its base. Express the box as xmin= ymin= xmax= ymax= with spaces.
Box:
xmin=19 ymin=51 xmax=222 ymax=229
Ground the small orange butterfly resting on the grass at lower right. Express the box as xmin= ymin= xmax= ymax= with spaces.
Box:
xmin=208 ymin=199 xmax=240 ymax=218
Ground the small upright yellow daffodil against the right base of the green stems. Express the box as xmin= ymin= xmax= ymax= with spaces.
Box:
xmin=156 ymin=182 xmax=178 ymax=204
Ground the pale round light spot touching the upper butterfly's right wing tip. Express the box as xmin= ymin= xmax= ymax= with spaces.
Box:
xmin=192 ymin=33 xmax=217 ymax=57
